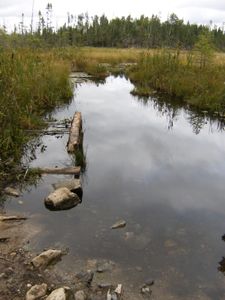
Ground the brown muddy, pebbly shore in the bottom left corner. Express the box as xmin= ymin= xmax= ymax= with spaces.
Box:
xmin=0 ymin=221 xmax=146 ymax=300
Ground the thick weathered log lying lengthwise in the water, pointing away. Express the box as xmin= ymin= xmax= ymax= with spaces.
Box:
xmin=67 ymin=112 xmax=82 ymax=153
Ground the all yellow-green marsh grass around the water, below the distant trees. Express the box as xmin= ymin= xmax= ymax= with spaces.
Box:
xmin=0 ymin=47 xmax=225 ymax=185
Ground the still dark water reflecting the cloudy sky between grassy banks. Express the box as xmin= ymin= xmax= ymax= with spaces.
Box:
xmin=5 ymin=76 xmax=225 ymax=300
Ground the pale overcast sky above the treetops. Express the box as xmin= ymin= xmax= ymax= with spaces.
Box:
xmin=0 ymin=0 xmax=225 ymax=27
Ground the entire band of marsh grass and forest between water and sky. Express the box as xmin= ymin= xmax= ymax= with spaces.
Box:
xmin=0 ymin=4 xmax=225 ymax=182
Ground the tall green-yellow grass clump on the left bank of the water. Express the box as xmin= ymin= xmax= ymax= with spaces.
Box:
xmin=0 ymin=49 xmax=72 ymax=163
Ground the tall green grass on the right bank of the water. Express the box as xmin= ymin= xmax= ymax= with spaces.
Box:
xmin=129 ymin=50 xmax=225 ymax=114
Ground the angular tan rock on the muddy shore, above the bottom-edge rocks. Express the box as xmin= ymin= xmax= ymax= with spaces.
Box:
xmin=31 ymin=249 xmax=63 ymax=268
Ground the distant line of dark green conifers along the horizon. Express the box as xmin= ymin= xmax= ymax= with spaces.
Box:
xmin=0 ymin=3 xmax=225 ymax=51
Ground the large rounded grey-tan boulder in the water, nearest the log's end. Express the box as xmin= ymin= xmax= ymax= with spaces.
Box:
xmin=45 ymin=187 xmax=81 ymax=210
